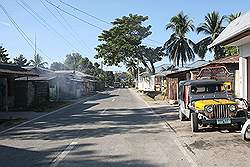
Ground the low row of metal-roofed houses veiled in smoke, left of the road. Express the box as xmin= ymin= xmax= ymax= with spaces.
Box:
xmin=15 ymin=67 xmax=95 ymax=105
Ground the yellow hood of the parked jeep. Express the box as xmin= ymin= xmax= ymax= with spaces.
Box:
xmin=194 ymin=99 xmax=236 ymax=110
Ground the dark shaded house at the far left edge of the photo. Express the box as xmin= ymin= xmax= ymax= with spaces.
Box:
xmin=0 ymin=64 xmax=36 ymax=111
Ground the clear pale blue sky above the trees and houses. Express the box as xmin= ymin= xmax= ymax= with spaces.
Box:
xmin=0 ymin=0 xmax=250 ymax=71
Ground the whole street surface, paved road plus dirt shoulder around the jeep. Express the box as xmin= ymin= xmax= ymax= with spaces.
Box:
xmin=0 ymin=89 xmax=250 ymax=167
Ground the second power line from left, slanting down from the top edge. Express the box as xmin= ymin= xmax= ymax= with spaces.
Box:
xmin=17 ymin=0 xmax=84 ymax=52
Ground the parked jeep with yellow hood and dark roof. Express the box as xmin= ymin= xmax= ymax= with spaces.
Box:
xmin=179 ymin=80 xmax=248 ymax=132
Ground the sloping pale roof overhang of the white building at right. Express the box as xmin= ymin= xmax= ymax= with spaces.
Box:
xmin=208 ymin=12 xmax=250 ymax=48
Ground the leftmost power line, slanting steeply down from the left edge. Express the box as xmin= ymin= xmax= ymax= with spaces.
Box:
xmin=0 ymin=4 xmax=48 ymax=60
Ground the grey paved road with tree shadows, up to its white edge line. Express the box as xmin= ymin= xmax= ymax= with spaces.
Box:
xmin=0 ymin=89 xmax=191 ymax=167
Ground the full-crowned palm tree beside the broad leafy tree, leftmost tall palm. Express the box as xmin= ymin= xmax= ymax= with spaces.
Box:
xmin=164 ymin=12 xmax=195 ymax=66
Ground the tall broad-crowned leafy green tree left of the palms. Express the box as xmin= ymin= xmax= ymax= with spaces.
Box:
xmin=96 ymin=14 xmax=161 ymax=73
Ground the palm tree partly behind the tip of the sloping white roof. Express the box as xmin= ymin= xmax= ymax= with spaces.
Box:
xmin=194 ymin=11 xmax=226 ymax=59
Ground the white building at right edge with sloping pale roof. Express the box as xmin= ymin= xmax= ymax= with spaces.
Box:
xmin=208 ymin=12 xmax=250 ymax=102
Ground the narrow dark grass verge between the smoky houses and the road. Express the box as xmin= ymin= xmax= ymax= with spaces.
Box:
xmin=31 ymin=101 xmax=73 ymax=112
